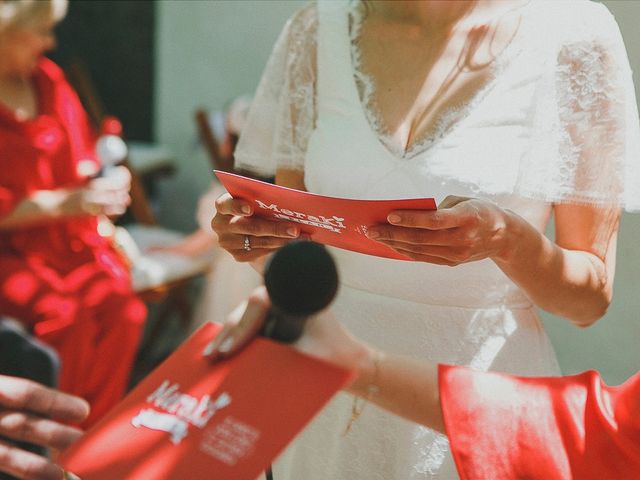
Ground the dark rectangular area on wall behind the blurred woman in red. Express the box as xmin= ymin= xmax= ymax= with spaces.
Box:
xmin=51 ymin=0 xmax=156 ymax=141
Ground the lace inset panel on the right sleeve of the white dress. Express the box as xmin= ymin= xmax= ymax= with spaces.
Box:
xmin=556 ymin=31 xmax=625 ymax=201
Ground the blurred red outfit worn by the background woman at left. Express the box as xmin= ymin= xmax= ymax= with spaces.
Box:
xmin=0 ymin=59 xmax=146 ymax=425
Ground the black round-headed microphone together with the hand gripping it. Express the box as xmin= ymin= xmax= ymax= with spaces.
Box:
xmin=209 ymin=241 xmax=374 ymax=394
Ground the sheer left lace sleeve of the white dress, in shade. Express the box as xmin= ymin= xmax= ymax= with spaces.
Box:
xmin=235 ymin=4 xmax=318 ymax=177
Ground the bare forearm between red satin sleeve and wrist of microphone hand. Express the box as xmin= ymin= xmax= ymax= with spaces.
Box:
xmin=348 ymin=347 xmax=445 ymax=433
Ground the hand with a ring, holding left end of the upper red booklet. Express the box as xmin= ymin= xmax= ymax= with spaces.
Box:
xmin=211 ymin=193 xmax=300 ymax=262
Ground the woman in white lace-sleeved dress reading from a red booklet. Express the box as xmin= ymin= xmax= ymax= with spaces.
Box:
xmin=212 ymin=0 xmax=640 ymax=480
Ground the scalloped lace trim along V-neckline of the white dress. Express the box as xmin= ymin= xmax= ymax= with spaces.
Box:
xmin=344 ymin=0 xmax=533 ymax=162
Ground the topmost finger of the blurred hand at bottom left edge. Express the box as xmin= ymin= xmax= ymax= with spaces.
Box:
xmin=0 ymin=375 xmax=89 ymax=422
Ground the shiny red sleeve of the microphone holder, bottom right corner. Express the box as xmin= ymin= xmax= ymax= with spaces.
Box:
xmin=439 ymin=365 xmax=640 ymax=480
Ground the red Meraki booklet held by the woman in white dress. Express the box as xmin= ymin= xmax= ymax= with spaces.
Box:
xmin=215 ymin=170 xmax=436 ymax=260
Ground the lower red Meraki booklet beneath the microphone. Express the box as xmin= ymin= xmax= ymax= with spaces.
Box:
xmin=60 ymin=323 xmax=351 ymax=480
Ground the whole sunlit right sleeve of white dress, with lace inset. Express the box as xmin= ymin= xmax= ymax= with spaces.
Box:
xmin=520 ymin=4 xmax=640 ymax=210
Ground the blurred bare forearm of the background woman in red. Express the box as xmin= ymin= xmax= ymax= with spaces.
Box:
xmin=0 ymin=190 xmax=77 ymax=230
